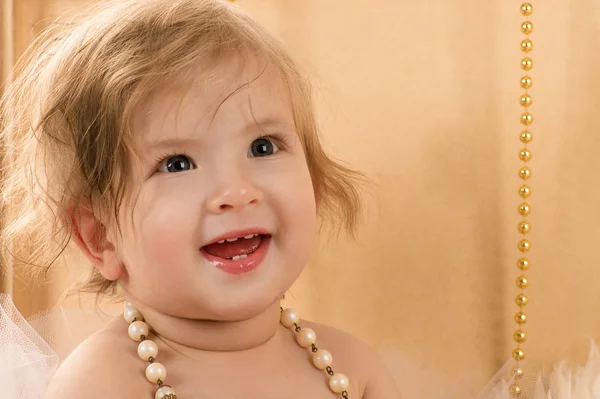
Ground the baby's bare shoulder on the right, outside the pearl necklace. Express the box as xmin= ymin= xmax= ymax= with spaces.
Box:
xmin=302 ymin=320 xmax=400 ymax=399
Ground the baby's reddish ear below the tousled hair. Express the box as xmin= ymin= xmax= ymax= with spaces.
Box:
xmin=66 ymin=204 xmax=125 ymax=281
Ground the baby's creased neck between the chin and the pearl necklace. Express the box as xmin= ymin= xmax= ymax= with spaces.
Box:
xmin=131 ymin=302 xmax=280 ymax=352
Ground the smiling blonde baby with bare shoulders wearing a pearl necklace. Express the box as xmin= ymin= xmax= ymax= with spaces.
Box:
xmin=1 ymin=0 xmax=399 ymax=399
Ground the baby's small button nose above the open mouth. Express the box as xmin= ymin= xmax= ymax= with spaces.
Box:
xmin=207 ymin=177 xmax=263 ymax=214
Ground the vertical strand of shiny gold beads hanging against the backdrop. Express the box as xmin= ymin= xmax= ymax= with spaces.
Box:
xmin=509 ymin=3 xmax=533 ymax=397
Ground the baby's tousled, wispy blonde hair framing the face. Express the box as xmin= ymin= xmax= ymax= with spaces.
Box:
xmin=0 ymin=0 xmax=361 ymax=293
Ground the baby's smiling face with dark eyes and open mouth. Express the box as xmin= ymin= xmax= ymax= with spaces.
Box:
xmin=113 ymin=57 xmax=316 ymax=320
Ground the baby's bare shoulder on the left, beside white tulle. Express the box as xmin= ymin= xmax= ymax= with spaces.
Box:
xmin=46 ymin=321 xmax=147 ymax=399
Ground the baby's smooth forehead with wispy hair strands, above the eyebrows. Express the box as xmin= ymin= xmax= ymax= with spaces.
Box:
xmin=132 ymin=57 xmax=293 ymax=146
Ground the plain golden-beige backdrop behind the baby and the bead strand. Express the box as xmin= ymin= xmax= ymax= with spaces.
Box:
xmin=2 ymin=0 xmax=600 ymax=397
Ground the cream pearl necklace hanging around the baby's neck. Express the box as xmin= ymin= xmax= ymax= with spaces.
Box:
xmin=123 ymin=301 xmax=350 ymax=399
